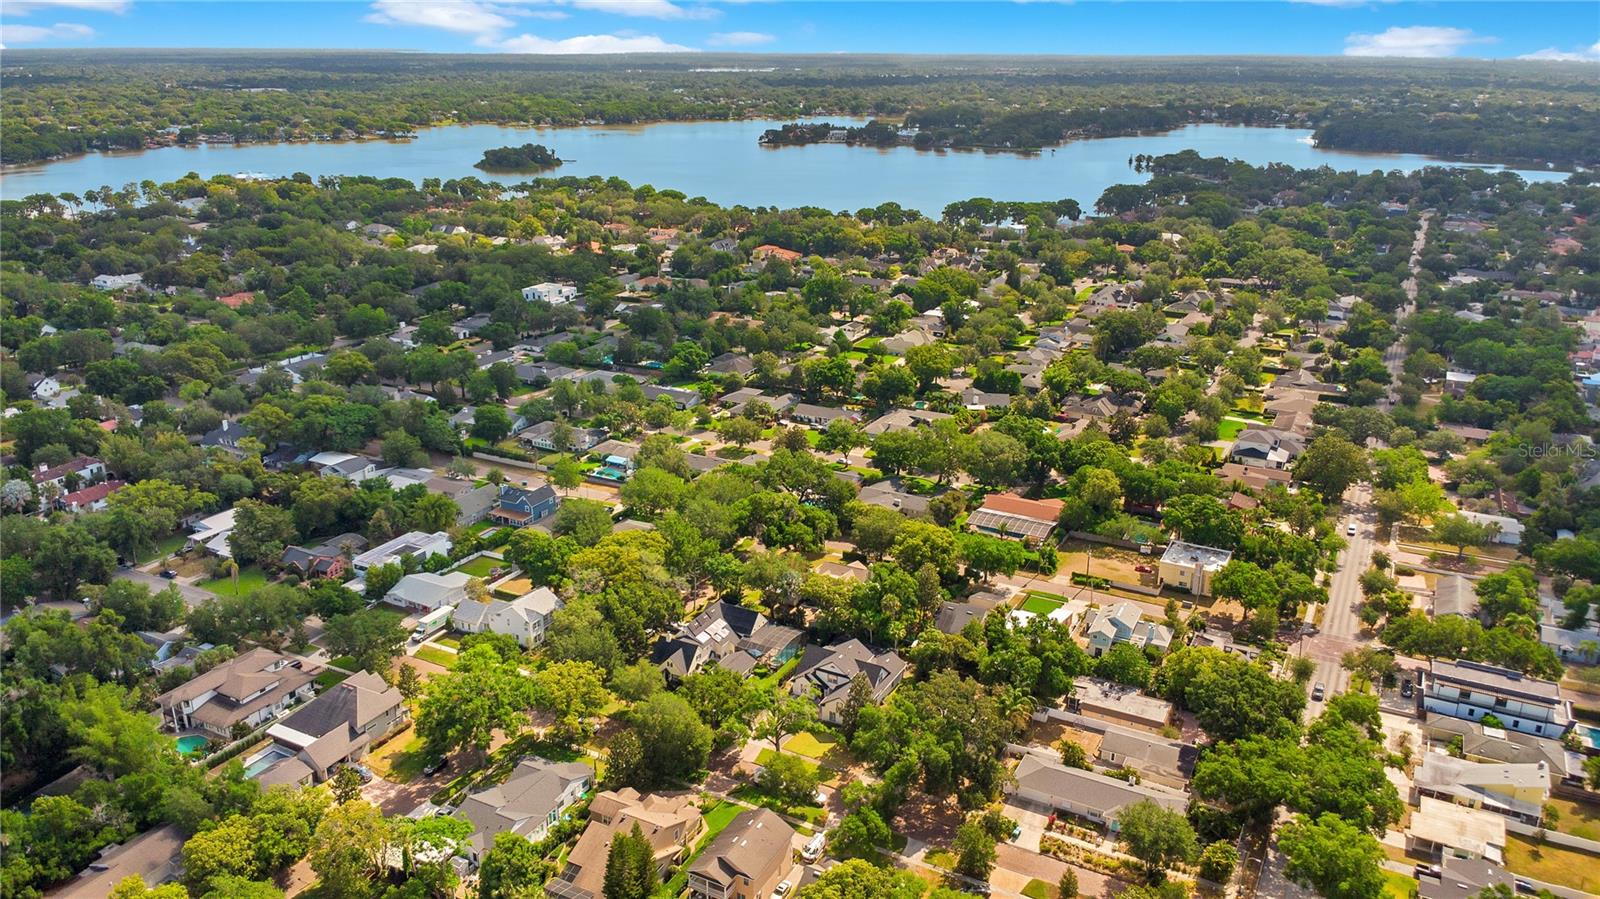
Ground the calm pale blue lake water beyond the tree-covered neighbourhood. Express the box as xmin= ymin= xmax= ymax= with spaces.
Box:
xmin=0 ymin=118 xmax=1566 ymax=216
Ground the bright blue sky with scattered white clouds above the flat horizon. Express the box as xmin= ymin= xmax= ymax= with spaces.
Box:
xmin=0 ymin=0 xmax=1600 ymax=62
